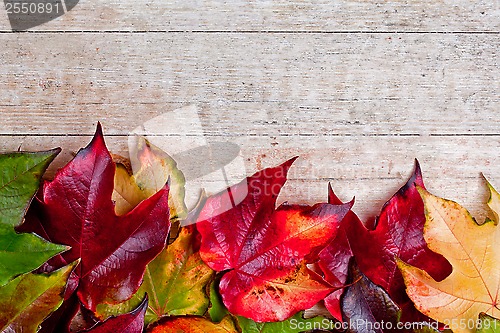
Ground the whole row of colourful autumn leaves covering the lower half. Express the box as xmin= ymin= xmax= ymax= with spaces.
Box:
xmin=0 ymin=126 xmax=500 ymax=333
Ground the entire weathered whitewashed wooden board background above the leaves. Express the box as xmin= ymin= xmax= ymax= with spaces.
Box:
xmin=0 ymin=0 xmax=500 ymax=219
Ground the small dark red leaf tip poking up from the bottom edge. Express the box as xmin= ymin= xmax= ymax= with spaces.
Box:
xmin=84 ymin=296 xmax=148 ymax=333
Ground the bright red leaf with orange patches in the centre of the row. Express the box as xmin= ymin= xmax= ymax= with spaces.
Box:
xmin=193 ymin=159 xmax=351 ymax=322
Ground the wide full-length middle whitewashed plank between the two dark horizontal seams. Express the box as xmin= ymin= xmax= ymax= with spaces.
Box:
xmin=0 ymin=33 xmax=500 ymax=137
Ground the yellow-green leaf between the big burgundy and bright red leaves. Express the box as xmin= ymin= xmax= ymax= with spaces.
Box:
xmin=97 ymin=226 xmax=214 ymax=324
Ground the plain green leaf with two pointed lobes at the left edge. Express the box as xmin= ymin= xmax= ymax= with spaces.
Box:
xmin=0 ymin=149 xmax=67 ymax=286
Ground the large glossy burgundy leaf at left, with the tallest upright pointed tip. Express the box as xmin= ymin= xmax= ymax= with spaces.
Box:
xmin=23 ymin=125 xmax=170 ymax=311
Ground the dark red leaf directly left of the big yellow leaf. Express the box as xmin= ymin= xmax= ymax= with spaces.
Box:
xmin=346 ymin=161 xmax=452 ymax=321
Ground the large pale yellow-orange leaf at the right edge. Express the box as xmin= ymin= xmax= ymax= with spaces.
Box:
xmin=398 ymin=184 xmax=500 ymax=333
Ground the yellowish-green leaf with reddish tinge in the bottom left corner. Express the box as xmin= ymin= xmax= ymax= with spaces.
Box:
xmin=0 ymin=262 xmax=76 ymax=333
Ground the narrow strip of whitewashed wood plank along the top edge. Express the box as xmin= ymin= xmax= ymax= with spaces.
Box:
xmin=0 ymin=0 xmax=500 ymax=32
